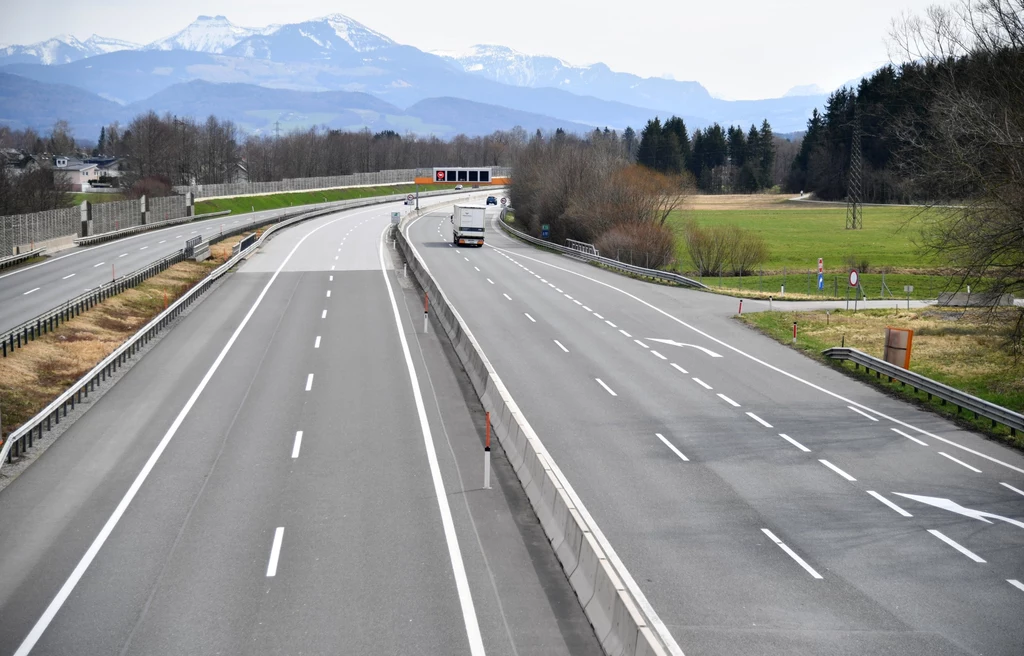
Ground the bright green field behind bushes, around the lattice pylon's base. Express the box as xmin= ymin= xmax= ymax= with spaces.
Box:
xmin=669 ymin=203 xmax=935 ymax=270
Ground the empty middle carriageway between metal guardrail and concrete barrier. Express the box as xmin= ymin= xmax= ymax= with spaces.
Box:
xmin=0 ymin=206 xmax=599 ymax=656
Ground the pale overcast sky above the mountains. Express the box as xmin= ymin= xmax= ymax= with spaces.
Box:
xmin=0 ymin=0 xmax=936 ymax=99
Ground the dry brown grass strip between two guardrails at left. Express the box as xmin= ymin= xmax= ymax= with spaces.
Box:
xmin=0 ymin=231 xmax=249 ymax=437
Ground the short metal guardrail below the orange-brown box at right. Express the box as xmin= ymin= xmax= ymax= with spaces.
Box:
xmin=821 ymin=346 xmax=1024 ymax=435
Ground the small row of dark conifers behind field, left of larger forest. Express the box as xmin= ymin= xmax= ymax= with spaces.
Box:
xmin=636 ymin=116 xmax=777 ymax=193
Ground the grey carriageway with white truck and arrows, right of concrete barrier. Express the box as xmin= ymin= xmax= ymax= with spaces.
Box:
xmin=407 ymin=209 xmax=1024 ymax=656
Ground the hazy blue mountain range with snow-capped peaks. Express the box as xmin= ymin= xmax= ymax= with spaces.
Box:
xmin=0 ymin=13 xmax=839 ymax=136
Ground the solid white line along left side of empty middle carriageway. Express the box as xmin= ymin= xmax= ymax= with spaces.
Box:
xmin=14 ymin=209 xmax=356 ymax=656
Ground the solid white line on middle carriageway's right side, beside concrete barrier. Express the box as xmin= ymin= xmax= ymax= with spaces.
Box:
xmin=379 ymin=226 xmax=484 ymax=656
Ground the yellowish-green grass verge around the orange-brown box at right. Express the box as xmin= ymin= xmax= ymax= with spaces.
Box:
xmin=740 ymin=307 xmax=1024 ymax=448
